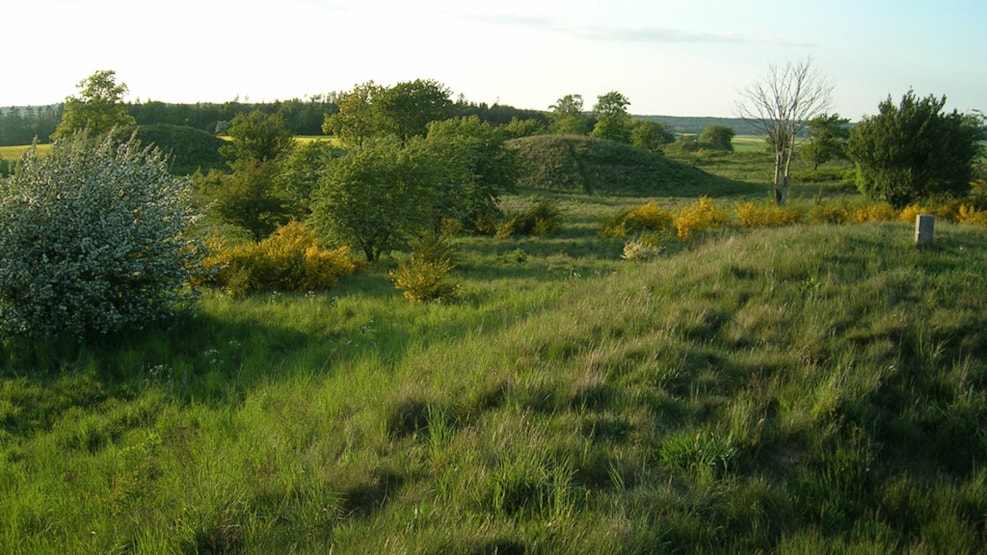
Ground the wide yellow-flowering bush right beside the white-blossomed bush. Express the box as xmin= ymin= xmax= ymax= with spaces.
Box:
xmin=199 ymin=222 xmax=357 ymax=296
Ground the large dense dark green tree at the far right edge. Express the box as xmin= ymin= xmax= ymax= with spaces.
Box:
xmin=847 ymin=91 xmax=985 ymax=208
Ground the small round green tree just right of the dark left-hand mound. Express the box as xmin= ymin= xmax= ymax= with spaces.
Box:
xmin=220 ymin=110 xmax=295 ymax=169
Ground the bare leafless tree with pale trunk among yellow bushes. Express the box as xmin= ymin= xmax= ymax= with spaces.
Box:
xmin=738 ymin=59 xmax=833 ymax=206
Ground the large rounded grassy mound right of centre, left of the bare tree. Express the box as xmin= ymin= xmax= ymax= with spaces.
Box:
xmin=510 ymin=135 xmax=750 ymax=197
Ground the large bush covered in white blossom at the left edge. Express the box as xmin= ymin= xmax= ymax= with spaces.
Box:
xmin=0 ymin=134 xmax=200 ymax=338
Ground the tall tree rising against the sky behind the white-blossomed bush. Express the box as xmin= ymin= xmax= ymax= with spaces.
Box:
xmin=51 ymin=70 xmax=136 ymax=140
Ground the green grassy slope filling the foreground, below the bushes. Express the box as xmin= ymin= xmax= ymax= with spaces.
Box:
xmin=0 ymin=211 xmax=987 ymax=553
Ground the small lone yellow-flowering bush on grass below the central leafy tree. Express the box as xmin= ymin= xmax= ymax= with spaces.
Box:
xmin=390 ymin=233 xmax=459 ymax=303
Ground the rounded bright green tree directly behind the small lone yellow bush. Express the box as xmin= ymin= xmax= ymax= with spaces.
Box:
xmin=311 ymin=135 xmax=441 ymax=262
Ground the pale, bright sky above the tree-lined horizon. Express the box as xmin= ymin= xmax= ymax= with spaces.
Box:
xmin=0 ymin=0 xmax=987 ymax=121
